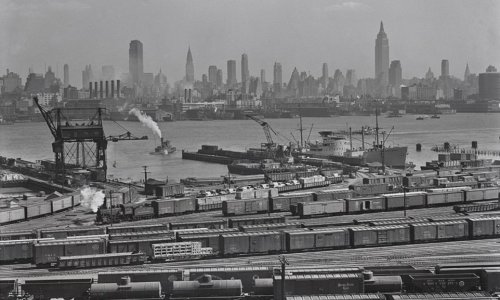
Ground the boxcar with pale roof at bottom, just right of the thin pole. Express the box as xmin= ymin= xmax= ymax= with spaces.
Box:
xmin=274 ymin=273 xmax=364 ymax=299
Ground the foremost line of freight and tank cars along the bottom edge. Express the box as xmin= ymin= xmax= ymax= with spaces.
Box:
xmin=0 ymin=263 xmax=500 ymax=300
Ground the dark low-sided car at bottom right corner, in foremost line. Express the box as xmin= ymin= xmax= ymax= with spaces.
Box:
xmin=408 ymin=273 xmax=481 ymax=293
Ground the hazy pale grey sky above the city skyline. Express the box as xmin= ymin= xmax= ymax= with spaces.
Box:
xmin=0 ymin=0 xmax=500 ymax=86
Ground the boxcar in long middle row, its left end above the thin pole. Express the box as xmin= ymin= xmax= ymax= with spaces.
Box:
xmin=285 ymin=228 xmax=349 ymax=252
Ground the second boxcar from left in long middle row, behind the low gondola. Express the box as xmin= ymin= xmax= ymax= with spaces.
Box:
xmin=33 ymin=239 xmax=106 ymax=265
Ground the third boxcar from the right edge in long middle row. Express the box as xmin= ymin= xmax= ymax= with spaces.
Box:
xmin=349 ymin=225 xmax=410 ymax=247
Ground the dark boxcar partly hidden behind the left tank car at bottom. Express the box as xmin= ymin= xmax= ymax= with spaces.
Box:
xmin=97 ymin=269 xmax=183 ymax=295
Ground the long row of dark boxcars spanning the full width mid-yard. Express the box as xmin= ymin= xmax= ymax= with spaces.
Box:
xmin=0 ymin=216 xmax=500 ymax=267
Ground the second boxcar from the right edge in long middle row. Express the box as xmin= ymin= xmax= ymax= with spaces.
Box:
xmin=410 ymin=220 xmax=469 ymax=243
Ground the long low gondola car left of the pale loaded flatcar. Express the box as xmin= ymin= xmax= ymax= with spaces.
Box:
xmin=57 ymin=252 xmax=147 ymax=269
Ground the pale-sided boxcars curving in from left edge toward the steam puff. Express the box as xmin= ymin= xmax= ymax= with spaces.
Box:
xmin=0 ymin=192 xmax=81 ymax=225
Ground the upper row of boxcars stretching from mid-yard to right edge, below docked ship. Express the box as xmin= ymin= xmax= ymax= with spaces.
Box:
xmin=222 ymin=187 xmax=500 ymax=217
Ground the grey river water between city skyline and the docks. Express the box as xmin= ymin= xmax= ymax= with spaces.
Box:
xmin=0 ymin=114 xmax=500 ymax=180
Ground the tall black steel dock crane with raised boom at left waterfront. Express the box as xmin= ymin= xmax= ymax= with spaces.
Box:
xmin=33 ymin=97 xmax=148 ymax=182
